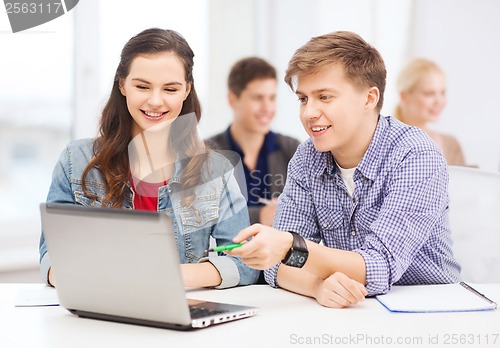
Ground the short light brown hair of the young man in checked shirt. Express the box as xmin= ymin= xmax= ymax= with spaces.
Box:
xmin=285 ymin=31 xmax=387 ymax=112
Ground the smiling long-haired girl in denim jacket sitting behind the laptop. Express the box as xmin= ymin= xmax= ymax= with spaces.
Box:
xmin=39 ymin=28 xmax=258 ymax=288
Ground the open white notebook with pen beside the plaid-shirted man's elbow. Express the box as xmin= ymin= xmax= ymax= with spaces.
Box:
xmin=376 ymin=282 xmax=497 ymax=313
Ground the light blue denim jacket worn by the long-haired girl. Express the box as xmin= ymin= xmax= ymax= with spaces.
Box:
xmin=39 ymin=139 xmax=259 ymax=289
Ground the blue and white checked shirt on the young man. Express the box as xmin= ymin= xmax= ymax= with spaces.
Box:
xmin=265 ymin=116 xmax=460 ymax=295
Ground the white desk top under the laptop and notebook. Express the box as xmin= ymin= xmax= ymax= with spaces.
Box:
xmin=0 ymin=284 xmax=500 ymax=348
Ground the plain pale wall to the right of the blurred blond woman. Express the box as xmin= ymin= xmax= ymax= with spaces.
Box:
xmin=411 ymin=0 xmax=500 ymax=171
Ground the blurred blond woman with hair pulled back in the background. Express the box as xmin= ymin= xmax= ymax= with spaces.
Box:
xmin=394 ymin=58 xmax=465 ymax=165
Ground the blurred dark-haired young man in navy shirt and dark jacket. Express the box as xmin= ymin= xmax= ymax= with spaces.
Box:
xmin=208 ymin=57 xmax=299 ymax=226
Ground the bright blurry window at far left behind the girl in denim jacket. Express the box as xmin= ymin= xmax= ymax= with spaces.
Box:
xmin=0 ymin=12 xmax=73 ymax=278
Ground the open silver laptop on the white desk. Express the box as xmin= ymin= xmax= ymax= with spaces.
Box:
xmin=40 ymin=203 xmax=257 ymax=330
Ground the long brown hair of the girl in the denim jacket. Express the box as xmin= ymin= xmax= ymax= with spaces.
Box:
xmin=82 ymin=28 xmax=205 ymax=207
